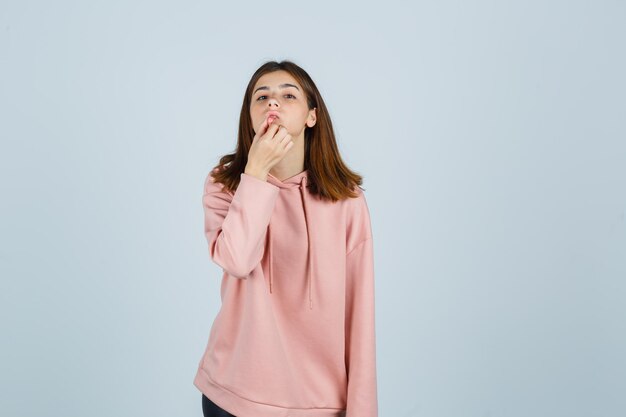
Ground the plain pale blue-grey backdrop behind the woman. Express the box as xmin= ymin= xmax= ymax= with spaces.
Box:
xmin=0 ymin=0 xmax=626 ymax=417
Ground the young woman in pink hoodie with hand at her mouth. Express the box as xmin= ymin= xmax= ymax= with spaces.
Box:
xmin=194 ymin=61 xmax=378 ymax=417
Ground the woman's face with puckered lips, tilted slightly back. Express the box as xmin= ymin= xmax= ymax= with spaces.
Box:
xmin=250 ymin=70 xmax=315 ymax=139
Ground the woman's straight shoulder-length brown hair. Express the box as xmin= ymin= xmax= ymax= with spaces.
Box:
xmin=207 ymin=60 xmax=363 ymax=202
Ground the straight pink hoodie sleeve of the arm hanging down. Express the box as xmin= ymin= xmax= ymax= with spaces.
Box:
xmin=346 ymin=196 xmax=378 ymax=417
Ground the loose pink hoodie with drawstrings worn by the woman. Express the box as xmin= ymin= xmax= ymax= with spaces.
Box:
xmin=193 ymin=170 xmax=378 ymax=417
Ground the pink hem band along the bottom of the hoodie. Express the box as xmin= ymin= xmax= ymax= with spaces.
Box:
xmin=193 ymin=366 xmax=346 ymax=417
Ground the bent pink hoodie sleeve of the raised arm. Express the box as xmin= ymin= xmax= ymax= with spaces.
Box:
xmin=202 ymin=173 xmax=279 ymax=278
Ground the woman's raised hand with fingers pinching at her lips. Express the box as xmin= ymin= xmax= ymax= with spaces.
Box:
xmin=244 ymin=117 xmax=293 ymax=180
